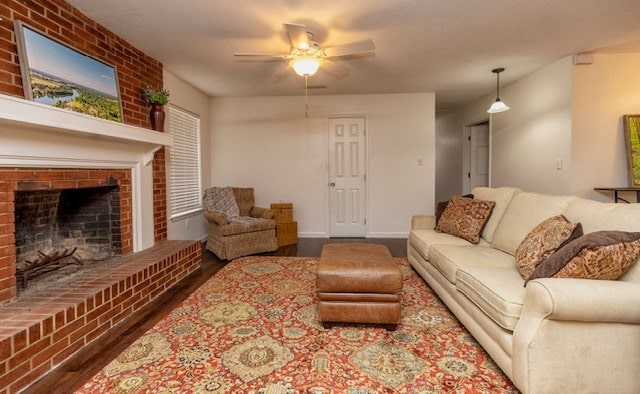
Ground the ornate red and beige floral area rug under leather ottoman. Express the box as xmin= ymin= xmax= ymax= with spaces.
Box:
xmin=78 ymin=257 xmax=517 ymax=394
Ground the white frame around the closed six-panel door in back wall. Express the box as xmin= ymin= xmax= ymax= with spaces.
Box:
xmin=324 ymin=113 xmax=371 ymax=238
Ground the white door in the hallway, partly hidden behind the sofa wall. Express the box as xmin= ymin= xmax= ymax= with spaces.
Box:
xmin=467 ymin=123 xmax=489 ymax=192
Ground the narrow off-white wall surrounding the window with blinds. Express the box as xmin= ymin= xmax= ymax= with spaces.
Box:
xmin=162 ymin=70 xmax=211 ymax=240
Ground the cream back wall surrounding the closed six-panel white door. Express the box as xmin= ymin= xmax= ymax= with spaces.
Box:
xmin=210 ymin=93 xmax=435 ymax=237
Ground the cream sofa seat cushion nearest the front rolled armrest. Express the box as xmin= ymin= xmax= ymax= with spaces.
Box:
xmin=456 ymin=267 xmax=525 ymax=331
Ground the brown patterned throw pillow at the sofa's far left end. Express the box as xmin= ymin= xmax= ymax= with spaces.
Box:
xmin=435 ymin=196 xmax=495 ymax=244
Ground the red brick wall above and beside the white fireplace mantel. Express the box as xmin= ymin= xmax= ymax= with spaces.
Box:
xmin=0 ymin=0 xmax=167 ymax=241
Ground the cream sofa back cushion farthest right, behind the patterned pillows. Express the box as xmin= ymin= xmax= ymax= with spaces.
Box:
xmin=563 ymin=197 xmax=640 ymax=282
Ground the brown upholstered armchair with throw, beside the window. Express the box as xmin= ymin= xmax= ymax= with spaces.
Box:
xmin=204 ymin=187 xmax=278 ymax=260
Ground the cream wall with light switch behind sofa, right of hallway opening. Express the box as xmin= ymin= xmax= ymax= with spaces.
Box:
xmin=491 ymin=58 xmax=572 ymax=194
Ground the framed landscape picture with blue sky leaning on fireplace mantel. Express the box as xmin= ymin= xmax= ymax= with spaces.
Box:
xmin=14 ymin=21 xmax=122 ymax=122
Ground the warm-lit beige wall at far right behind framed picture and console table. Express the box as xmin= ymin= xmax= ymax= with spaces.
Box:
xmin=571 ymin=53 xmax=640 ymax=202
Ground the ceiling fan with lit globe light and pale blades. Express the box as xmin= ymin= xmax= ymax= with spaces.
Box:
xmin=233 ymin=23 xmax=376 ymax=80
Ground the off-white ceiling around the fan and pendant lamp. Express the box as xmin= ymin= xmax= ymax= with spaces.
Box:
xmin=67 ymin=0 xmax=640 ymax=110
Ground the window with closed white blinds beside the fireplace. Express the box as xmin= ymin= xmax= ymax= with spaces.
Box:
xmin=167 ymin=104 xmax=202 ymax=219
